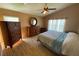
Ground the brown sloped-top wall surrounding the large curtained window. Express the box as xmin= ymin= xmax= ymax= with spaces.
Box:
xmin=43 ymin=4 xmax=79 ymax=32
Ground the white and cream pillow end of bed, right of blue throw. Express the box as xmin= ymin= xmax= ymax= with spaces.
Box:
xmin=62 ymin=32 xmax=79 ymax=55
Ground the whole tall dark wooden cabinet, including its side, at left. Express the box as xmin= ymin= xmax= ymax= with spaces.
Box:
xmin=2 ymin=21 xmax=21 ymax=47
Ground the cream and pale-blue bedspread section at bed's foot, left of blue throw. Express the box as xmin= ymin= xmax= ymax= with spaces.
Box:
xmin=38 ymin=31 xmax=62 ymax=47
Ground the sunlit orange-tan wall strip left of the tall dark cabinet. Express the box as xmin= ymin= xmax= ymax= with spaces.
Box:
xmin=0 ymin=22 xmax=8 ymax=49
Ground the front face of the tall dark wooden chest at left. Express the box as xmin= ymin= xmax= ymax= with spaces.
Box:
xmin=7 ymin=22 xmax=21 ymax=45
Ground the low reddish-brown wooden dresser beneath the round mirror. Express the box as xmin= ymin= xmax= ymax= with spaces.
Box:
xmin=26 ymin=26 xmax=40 ymax=37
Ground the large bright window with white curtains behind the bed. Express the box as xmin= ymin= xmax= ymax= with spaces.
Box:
xmin=48 ymin=19 xmax=65 ymax=32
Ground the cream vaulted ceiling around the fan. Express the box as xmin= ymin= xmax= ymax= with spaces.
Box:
xmin=0 ymin=3 xmax=72 ymax=16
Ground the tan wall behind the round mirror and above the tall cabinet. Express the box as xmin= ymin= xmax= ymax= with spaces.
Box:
xmin=0 ymin=8 xmax=43 ymax=38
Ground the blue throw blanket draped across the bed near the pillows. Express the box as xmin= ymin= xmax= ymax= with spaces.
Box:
xmin=51 ymin=33 xmax=67 ymax=54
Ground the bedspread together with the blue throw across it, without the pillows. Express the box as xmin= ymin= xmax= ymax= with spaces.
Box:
xmin=38 ymin=31 xmax=67 ymax=54
